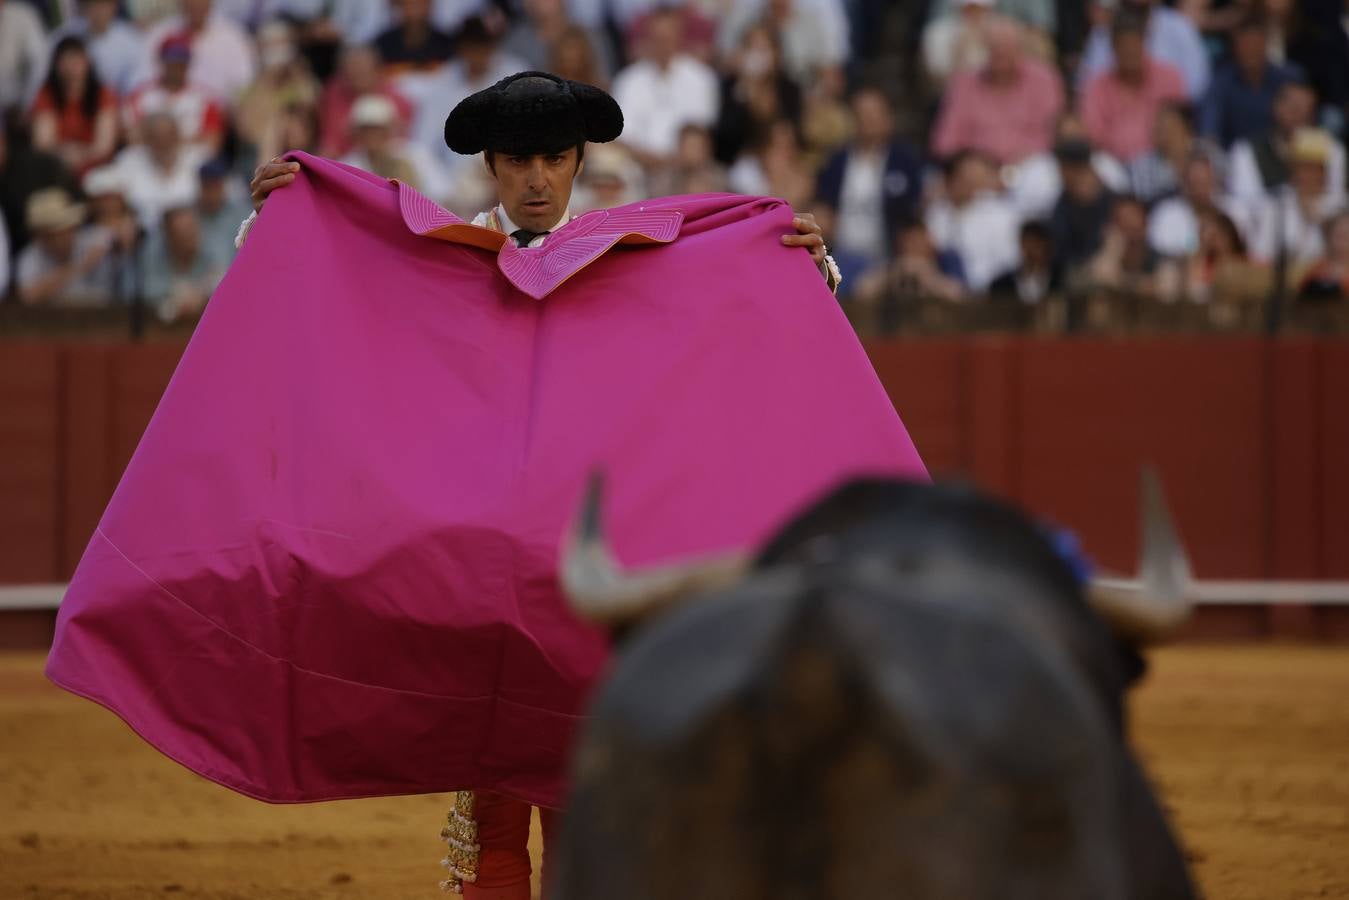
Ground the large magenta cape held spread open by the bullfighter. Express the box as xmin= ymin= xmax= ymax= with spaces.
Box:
xmin=47 ymin=155 xmax=925 ymax=806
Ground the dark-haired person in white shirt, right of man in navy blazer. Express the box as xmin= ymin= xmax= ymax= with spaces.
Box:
xmin=927 ymin=150 xmax=1021 ymax=294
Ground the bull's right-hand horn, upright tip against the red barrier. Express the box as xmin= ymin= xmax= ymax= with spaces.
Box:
xmin=1087 ymin=467 xmax=1194 ymax=642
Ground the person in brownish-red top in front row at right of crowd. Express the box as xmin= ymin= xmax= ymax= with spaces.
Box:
xmin=1159 ymin=210 xmax=1273 ymax=317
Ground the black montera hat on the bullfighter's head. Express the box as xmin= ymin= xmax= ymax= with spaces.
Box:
xmin=445 ymin=72 xmax=623 ymax=157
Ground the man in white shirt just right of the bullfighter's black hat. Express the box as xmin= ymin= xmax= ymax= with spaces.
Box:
xmin=614 ymin=8 xmax=718 ymax=170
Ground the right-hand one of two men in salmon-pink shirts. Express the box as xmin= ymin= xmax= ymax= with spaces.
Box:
xmin=1081 ymin=12 xmax=1186 ymax=163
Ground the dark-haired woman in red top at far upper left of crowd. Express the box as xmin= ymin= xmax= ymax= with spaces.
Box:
xmin=32 ymin=38 xmax=117 ymax=175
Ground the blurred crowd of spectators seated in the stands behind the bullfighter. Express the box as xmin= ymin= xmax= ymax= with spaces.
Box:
xmin=0 ymin=0 xmax=1349 ymax=333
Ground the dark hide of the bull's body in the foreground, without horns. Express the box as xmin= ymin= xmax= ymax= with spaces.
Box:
xmin=550 ymin=482 xmax=1195 ymax=900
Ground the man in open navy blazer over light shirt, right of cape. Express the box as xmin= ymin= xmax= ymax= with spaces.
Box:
xmin=815 ymin=86 xmax=923 ymax=279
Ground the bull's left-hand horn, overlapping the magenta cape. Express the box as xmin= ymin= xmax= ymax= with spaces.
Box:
xmin=558 ymin=474 xmax=750 ymax=623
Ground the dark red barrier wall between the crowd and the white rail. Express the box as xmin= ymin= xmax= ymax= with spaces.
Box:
xmin=0 ymin=337 xmax=1349 ymax=630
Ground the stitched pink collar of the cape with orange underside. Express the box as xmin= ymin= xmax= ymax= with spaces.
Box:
xmin=398 ymin=182 xmax=684 ymax=300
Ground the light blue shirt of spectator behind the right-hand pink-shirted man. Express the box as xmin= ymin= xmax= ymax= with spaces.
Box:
xmin=1078 ymin=0 xmax=1210 ymax=103
